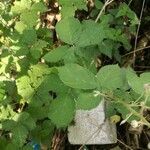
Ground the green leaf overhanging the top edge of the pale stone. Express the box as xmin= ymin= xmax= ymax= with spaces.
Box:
xmin=76 ymin=92 xmax=101 ymax=110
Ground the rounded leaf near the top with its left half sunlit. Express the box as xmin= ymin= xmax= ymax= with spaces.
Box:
xmin=56 ymin=18 xmax=81 ymax=45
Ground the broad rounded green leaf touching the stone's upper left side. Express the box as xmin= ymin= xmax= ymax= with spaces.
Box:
xmin=48 ymin=96 xmax=75 ymax=128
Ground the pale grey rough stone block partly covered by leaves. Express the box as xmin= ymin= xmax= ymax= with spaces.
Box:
xmin=68 ymin=102 xmax=117 ymax=145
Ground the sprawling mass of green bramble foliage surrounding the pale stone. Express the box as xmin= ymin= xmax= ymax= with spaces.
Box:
xmin=0 ymin=0 xmax=150 ymax=150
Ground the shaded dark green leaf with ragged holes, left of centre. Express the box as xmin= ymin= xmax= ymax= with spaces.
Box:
xmin=28 ymin=74 xmax=69 ymax=120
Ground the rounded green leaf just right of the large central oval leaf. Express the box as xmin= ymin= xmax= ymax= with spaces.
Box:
xmin=97 ymin=65 xmax=124 ymax=90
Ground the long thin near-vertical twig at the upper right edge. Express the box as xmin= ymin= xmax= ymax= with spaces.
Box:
xmin=133 ymin=0 xmax=145 ymax=66
